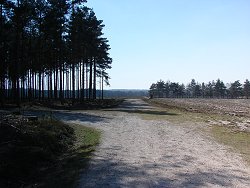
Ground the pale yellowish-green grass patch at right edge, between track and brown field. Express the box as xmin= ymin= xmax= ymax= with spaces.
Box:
xmin=211 ymin=126 xmax=250 ymax=164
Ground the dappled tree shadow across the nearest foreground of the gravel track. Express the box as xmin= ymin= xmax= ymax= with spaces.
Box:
xmin=78 ymin=152 xmax=250 ymax=188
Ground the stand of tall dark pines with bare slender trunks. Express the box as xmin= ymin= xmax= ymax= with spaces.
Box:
xmin=0 ymin=0 xmax=112 ymax=104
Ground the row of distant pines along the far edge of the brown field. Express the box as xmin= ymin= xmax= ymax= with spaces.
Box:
xmin=149 ymin=79 xmax=250 ymax=99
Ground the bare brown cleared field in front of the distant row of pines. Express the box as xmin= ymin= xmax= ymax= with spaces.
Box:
xmin=148 ymin=99 xmax=250 ymax=132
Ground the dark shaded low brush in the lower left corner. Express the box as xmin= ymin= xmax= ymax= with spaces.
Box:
xmin=0 ymin=116 xmax=75 ymax=187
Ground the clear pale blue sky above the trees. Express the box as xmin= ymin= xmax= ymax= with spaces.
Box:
xmin=87 ymin=0 xmax=250 ymax=89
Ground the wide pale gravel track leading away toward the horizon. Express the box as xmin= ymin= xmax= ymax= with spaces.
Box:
xmin=60 ymin=100 xmax=250 ymax=188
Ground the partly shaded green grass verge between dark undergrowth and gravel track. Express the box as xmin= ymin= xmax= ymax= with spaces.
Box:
xmin=41 ymin=124 xmax=101 ymax=188
